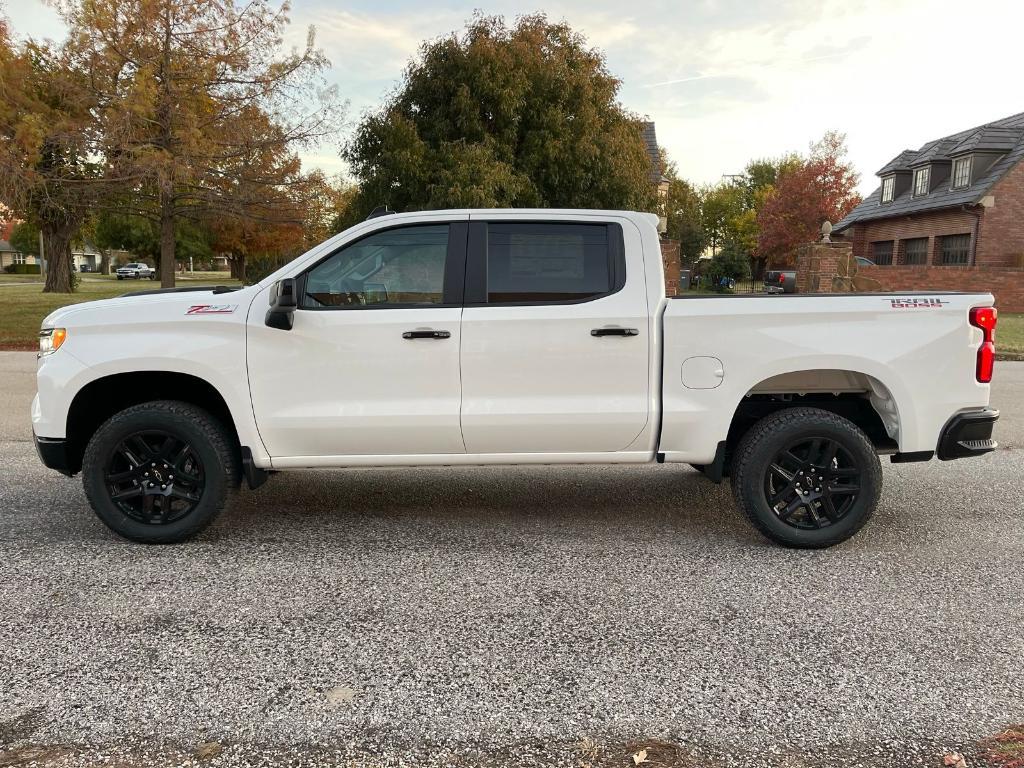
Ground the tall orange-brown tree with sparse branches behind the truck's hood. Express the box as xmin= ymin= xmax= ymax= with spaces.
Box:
xmin=58 ymin=0 xmax=338 ymax=287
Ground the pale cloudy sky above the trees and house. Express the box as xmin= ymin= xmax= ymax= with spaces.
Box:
xmin=0 ymin=0 xmax=1024 ymax=195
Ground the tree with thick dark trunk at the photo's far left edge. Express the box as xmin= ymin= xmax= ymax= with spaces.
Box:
xmin=0 ymin=24 xmax=100 ymax=293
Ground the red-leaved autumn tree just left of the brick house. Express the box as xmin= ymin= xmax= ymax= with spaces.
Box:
xmin=758 ymin=131 xmax=860 ymax=265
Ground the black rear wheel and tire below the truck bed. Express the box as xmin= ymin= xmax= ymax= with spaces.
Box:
xmin=732 ymin=408 xmax=882 ymax=549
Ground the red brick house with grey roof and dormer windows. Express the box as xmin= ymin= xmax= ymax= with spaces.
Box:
xmin=834 ymin=113 xmax=1024 ymax=311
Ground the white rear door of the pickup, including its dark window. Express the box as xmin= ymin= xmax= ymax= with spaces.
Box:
xmin=462 ymin=213 xmax=651 ymax=454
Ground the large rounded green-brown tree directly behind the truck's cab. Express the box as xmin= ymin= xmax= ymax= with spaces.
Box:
xmin=343 ymin=14 xmax=654 ymax=219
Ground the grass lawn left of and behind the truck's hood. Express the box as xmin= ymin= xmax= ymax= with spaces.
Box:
xmin=0 ymin=272 xmax=239 ymax=349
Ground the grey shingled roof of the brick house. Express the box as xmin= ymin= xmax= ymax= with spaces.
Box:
xmin=833 ymin=113 xmax=1024 ymax=231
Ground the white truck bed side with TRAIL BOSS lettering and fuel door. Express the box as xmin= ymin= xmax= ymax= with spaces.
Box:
xmin=660 ymin=292 xmax=993 ymax=464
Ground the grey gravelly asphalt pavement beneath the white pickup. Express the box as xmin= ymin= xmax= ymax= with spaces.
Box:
xmin=0 ymin=353 xmax=1024 ymax=768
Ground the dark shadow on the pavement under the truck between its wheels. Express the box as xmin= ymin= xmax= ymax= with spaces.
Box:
xmin=214 ymin=465 xmax=761 ymax=539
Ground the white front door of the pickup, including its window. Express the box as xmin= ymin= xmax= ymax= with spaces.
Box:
xmin=247 ymin=220 xmax=467 ymax=465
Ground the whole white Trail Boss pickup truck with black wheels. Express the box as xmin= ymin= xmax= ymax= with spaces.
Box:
xmin=32 ymin=210 xmax=998 ymax=548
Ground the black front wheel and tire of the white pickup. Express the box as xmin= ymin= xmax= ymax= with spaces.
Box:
xmin=82 ymin=400 xmax=241 ymax=544
